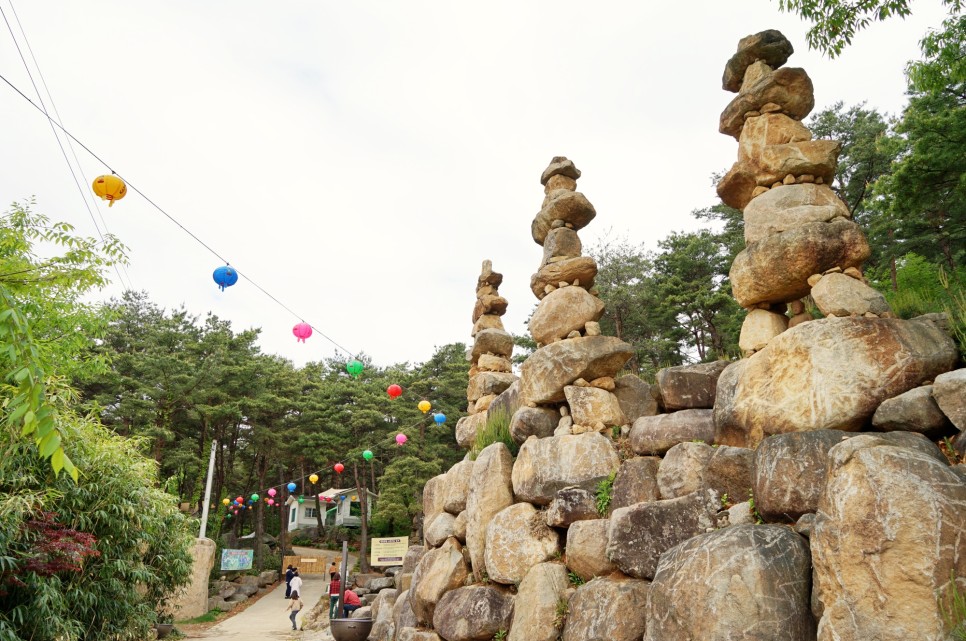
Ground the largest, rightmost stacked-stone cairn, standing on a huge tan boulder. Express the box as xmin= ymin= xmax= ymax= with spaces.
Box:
xmin=718 ymin=30 xmax=891 ymax=356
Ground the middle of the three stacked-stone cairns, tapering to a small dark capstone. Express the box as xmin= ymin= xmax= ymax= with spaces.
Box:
xmin=510 ymin=156 xmax=632 ymax=442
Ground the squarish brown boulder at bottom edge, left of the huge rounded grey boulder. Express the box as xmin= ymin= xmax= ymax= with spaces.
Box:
xmin=563 ymin=577 xmax=650 ymax=641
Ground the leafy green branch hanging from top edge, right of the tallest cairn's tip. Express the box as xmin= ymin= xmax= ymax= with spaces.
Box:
xmin=778 ymin=0 xmax=963 ymax=58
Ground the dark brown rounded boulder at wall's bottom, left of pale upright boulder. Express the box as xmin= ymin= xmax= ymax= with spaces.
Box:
xmin=433 ymin=585 xmax=513 ymax=641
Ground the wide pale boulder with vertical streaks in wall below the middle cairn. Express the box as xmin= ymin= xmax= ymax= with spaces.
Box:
xmin=516 ymin=432 xmax=620 ymax=504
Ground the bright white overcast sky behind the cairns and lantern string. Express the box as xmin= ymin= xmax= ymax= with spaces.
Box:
xmin=0 ymin=0 xmax=943 ymax=365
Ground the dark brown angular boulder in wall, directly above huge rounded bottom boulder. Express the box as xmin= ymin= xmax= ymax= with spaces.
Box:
xmin=607 ymin=490 xmax=719 ymax=579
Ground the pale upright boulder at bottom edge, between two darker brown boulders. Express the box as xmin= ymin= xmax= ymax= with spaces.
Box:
xmin=507 ymin=563 xmax=569 ymax=641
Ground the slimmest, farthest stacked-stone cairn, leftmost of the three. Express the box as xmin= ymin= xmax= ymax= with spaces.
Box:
xmin=456 ymin=260 xmax=517 ymax=449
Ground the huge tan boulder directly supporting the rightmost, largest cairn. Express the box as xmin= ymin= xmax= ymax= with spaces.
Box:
xmin=714 ymin=318 xmax=958 ymax=447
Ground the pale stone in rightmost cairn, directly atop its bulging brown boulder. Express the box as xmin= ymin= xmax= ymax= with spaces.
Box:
xmin=742 ymin=182 xmax=852 ymax=245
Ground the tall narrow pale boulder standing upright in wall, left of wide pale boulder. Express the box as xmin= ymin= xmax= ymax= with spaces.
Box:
xmin=466 ymin=443 xmax=513 ymax=581
